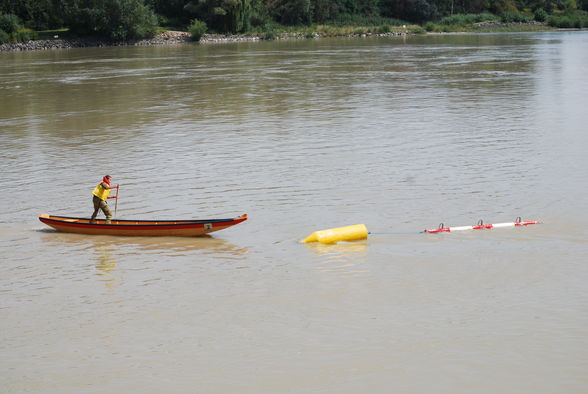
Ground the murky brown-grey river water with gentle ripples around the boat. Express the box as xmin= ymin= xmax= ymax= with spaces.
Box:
xmin=0 ymin=32 xmax=588 ymax=394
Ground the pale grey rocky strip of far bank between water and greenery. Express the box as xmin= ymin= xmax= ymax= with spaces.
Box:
xmin=0 ymin=31 xmax=409 ymax=52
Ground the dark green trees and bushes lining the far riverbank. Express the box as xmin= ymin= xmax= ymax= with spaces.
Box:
xmin=0 ymin=0 xmax=588 ymax=40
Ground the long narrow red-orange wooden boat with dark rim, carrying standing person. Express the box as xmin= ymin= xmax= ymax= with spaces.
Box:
xmin=39 ymin=214 xmax=247 ymax=237
